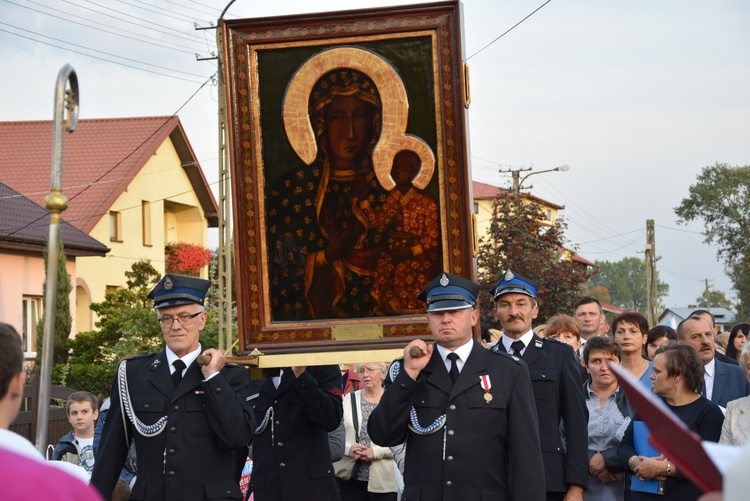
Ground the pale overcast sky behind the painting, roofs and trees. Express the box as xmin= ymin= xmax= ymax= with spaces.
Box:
xmin=0 ymin=0 xmax=750 ymax=306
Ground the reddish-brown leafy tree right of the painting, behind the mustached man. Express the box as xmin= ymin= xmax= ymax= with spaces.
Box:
xmin=477 ymin=192 xmax=588 ymax=325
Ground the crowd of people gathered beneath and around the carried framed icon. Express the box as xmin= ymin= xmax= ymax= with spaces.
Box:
xmin=5 ymin=270 xmax=750 ymax=501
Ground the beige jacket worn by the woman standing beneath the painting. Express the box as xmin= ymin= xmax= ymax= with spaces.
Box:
xmin=334 ymin=390 xmax=399 ymax=493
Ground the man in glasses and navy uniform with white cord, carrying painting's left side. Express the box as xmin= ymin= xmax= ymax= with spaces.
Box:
xmin=91 ymin=275 xmax=250 ymax=501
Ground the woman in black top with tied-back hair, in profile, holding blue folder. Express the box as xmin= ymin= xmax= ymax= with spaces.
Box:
xmin=617 ymin=342 xmax=724 ymax=501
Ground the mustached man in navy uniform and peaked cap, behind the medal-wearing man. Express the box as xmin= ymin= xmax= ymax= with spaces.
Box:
xmin=492 ymin=270 xmax=589 ymax=501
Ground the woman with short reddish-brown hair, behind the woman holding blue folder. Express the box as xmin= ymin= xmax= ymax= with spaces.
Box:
xmin=612 ymin=311 xmax=653 ymax=389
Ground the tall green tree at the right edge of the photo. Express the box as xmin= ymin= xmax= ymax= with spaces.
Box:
xmin=674 ymin=162 xmax=750 ymax=318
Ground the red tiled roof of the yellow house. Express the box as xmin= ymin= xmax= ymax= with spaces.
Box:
xmin=0 ymin=117 xmax=218 ymax=233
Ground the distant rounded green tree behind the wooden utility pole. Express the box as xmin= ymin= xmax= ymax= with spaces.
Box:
xmin=589 ymin=257 xmax=669 ymax=314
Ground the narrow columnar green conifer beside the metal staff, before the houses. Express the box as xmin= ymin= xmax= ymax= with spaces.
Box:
xmin=34 ymin=242 xmax=73 ymax=384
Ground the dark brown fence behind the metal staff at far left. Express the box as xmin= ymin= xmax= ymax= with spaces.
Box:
xmin=10 ymin=374 xmax=76 ymax=445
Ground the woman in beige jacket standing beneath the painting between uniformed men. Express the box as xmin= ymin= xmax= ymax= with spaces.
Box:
xmin=334 ymin=363 xmax=399 ymax=501
